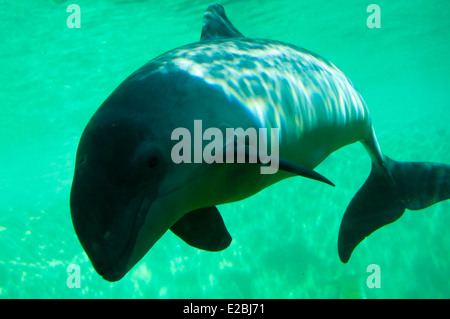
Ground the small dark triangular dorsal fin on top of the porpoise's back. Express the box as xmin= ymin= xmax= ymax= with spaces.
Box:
xmin=200 ymin=3 xmax=244 ymax=40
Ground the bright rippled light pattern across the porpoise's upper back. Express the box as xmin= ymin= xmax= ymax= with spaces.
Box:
xmin=135 ymin=38 xmax=370 ymax=146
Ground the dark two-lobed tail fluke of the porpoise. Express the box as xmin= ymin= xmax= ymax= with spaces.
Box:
xmin=338 ymin=156 xmax=450 ymax=263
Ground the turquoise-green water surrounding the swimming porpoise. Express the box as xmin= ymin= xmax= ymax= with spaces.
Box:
xmin=0 ymin=0 xmax=450 ymax=298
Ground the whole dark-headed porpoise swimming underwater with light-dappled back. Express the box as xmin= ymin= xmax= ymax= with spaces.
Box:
xmin=70 ymin=4 xmax=450 ymax=281
